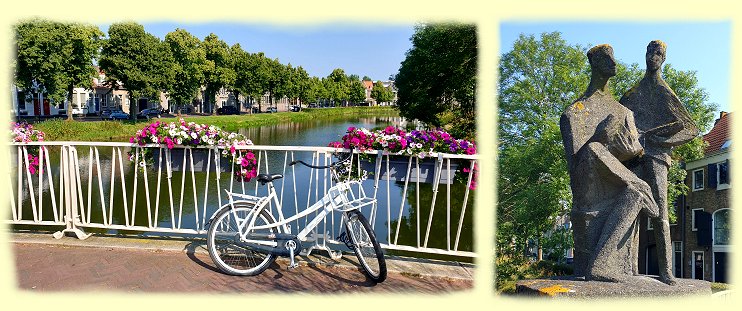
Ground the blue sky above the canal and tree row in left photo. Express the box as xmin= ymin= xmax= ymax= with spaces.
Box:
xmin=101 ymin=22 xmax=414 ymax=81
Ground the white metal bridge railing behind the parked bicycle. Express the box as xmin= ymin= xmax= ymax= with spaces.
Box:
xmin=5 ymin=142 xmax=477 ymax=257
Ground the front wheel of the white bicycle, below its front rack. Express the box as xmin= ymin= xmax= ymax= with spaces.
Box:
xmin=345 ymin=210 xmax=386 ymax=283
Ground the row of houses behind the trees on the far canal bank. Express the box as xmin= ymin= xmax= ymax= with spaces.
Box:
xmin=11 ymin=70 xmax=396 ymax=117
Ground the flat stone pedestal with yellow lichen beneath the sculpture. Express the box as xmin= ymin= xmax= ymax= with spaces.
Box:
xmin=515 ymin=276 xmax=711 ymax=299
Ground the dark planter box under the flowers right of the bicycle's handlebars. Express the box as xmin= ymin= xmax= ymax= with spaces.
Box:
xmin=361 ymin=157 xmax=459 ymax=184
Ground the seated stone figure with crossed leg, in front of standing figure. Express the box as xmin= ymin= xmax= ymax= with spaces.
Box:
xmin=560 ymin=45 xmax=658 ymax=282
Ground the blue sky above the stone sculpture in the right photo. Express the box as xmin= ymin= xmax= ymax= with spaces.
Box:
xmin=500 ymin=22 xmax=731 ymax=111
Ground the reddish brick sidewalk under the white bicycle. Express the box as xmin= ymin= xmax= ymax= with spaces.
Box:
xmin=10 ymin=233 xmax=473 ymax=293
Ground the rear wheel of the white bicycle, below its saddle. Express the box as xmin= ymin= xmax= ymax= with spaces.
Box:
xmin=206 ymin=202 xmax=277 ymax=276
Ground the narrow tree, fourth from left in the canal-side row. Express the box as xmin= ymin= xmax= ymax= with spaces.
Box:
xmin=203 ymin=33 xmax=236 ymax=114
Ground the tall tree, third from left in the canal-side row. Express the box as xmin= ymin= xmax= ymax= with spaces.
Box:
xmin=165 ymin=28 xmax=207 ymax=114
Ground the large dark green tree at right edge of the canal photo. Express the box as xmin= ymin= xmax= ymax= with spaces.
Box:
xmin=394 ymin=24 xmax=477 ymax=136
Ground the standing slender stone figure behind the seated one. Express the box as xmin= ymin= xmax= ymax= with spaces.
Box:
xmin=620 ymin=40 xmax=698 ymax=285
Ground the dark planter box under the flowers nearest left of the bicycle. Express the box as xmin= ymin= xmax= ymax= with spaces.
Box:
xmin=152 ymin=147 xmax=232 ymax=173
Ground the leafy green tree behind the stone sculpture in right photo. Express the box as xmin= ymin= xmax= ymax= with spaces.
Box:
xmin=497 ymin=32 xmax=715 ymax=255
